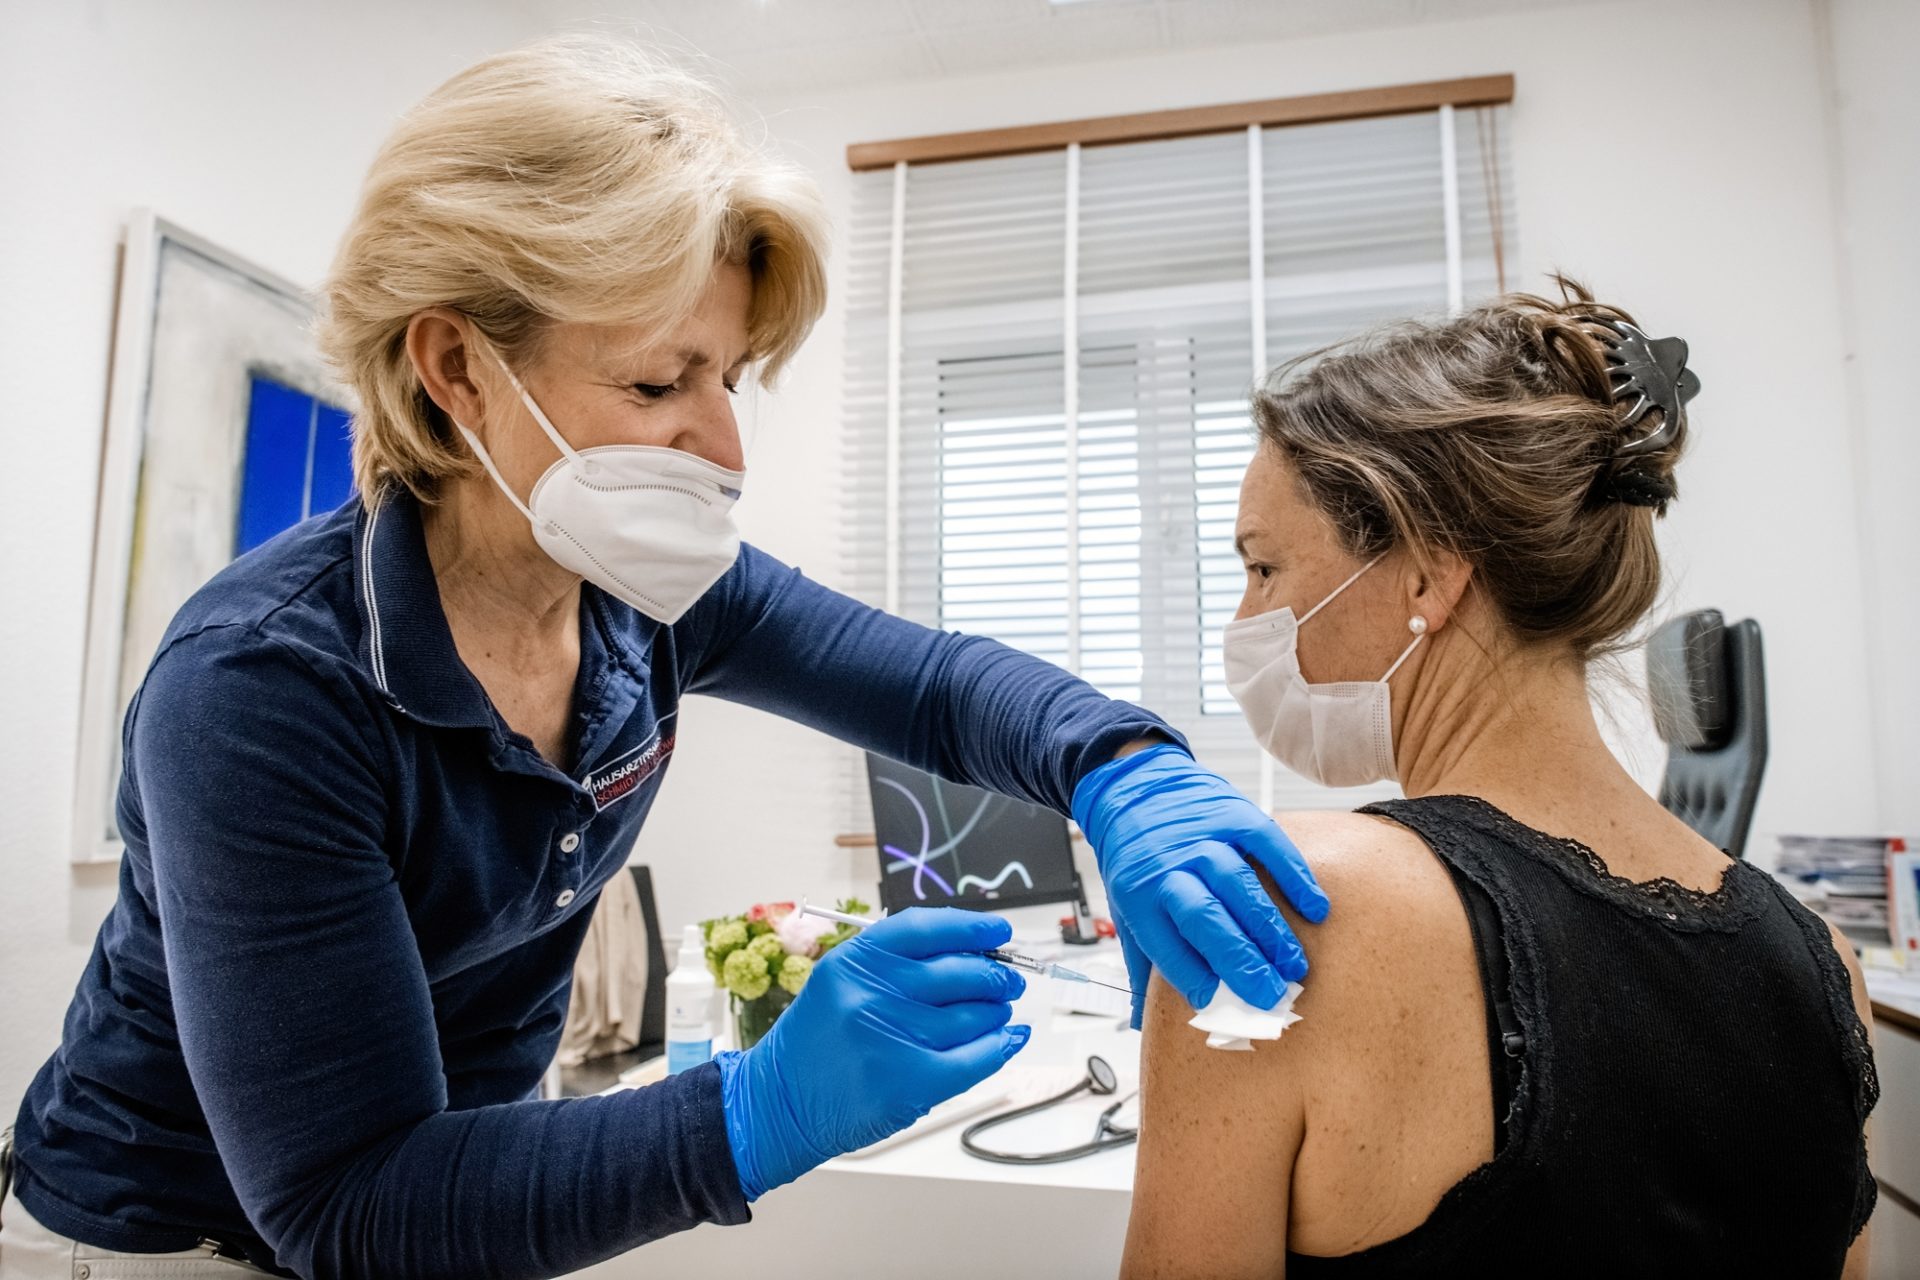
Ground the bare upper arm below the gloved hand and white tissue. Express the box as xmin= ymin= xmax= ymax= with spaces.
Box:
xmin=1121 ymin=977 xmax=1306 ymax=1278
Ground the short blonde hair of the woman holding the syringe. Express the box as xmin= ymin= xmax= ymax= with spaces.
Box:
xmin=319 ymin=38 xmax=828 ymax=501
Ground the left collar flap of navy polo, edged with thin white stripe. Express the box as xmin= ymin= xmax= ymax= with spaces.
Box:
xmin=353 ymin=489 xmax=495 ymax=729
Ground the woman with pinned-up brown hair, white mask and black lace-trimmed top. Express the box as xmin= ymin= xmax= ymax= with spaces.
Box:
xmin=1125 ymin=282 xmax=1876 ymax=1278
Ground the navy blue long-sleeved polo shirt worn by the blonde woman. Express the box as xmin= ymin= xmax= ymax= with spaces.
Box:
xmin=15 ymin=495 xmax=1169 ymax=1276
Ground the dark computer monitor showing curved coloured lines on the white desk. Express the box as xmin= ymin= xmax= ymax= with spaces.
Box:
xmin=866 ymin=752 xmax=1081 ymax=912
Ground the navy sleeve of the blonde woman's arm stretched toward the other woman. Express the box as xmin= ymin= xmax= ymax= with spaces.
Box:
xmin=676 ymin=547 xmax=1185 ymax=814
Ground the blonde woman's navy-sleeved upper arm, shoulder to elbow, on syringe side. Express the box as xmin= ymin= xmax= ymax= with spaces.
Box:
xmin=129 ymin=629 xmax=445 ymax=1245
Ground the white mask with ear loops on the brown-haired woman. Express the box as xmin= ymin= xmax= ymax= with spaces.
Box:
xmin=1221 ymin=558 xmax=1427 ymax=787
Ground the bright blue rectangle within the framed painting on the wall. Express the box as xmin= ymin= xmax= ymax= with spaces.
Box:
xmin=234 ymin=372 xmax=353 ymax=555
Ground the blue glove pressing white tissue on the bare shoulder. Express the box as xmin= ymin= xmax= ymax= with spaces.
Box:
xmin=1073 ymin=745 xmax=1327 ymax=1027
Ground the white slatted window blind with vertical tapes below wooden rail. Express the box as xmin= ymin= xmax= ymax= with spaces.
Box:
xmin=843 ymin=97 xmax=1513 ymax=829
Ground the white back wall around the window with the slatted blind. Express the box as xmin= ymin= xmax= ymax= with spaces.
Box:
xmin=675 ymin=0 xmax=1889 ymax=875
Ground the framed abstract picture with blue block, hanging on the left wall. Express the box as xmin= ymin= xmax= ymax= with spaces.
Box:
xmin=73 ymin=209 xmax=351 ymax=862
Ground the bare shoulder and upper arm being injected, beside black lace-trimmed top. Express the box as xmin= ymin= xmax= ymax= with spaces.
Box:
xmin=1123 ymin=812 xmax=1492 ymax=1276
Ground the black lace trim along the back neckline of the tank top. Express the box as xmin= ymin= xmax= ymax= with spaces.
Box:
xmin=1405 ymin=796 xmax=1772 ymax=933
